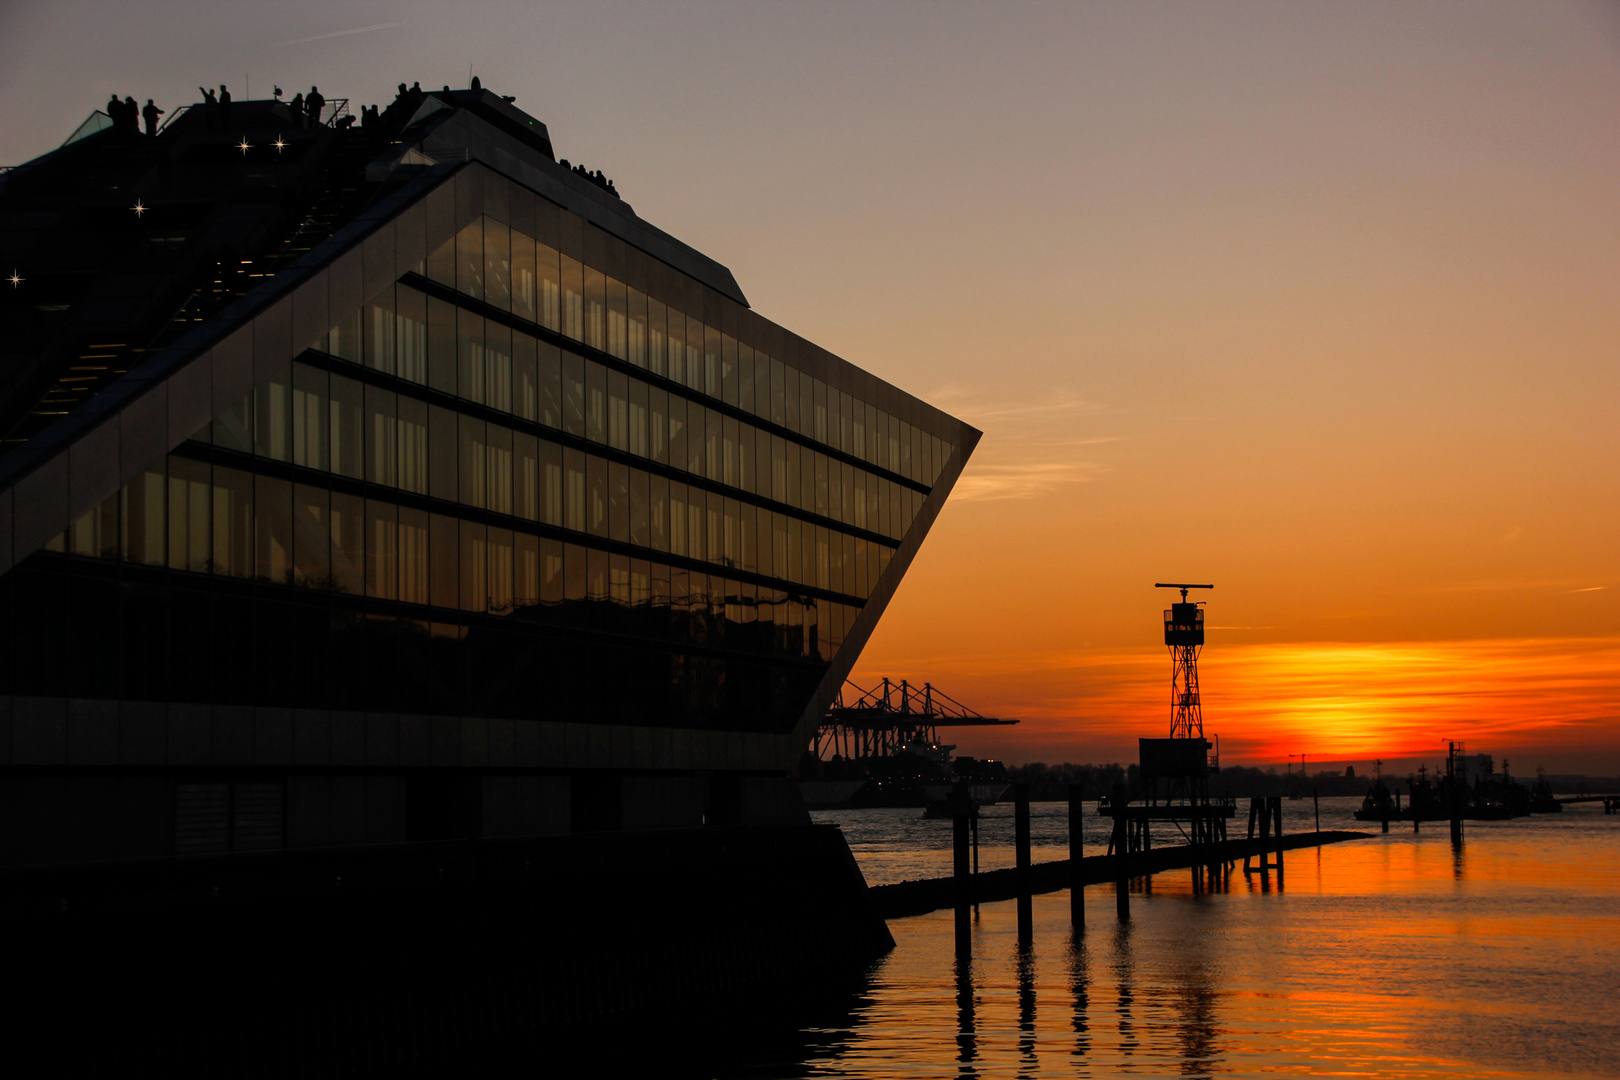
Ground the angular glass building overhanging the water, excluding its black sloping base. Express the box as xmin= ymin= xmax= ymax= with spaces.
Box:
xmin=0 ymin=91 xmax=978 ymax=1062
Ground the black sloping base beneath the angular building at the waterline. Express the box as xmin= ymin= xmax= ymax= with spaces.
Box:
xmin=0 ymin=826 xmax=893 ymax=1075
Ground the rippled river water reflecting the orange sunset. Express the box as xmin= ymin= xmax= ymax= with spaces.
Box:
xmin=723 ymin=798 xmax=1620 ymax=1077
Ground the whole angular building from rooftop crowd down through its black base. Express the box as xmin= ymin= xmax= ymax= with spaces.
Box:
xmin=0 ymin=82 xmax=978 ymax=1075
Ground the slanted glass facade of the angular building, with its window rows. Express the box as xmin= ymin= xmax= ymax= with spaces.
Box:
xmin=0 ymin=165 xmax=954 ymax=744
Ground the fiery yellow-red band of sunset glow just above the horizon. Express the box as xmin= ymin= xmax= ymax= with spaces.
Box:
xmin=855 ymin=638 xmax=1620 ymax=774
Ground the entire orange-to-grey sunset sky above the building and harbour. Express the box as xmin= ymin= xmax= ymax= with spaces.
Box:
xmin=0 ymin=0 xmax=1620 ymax=774
